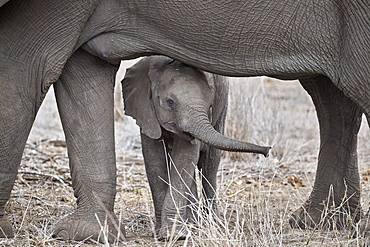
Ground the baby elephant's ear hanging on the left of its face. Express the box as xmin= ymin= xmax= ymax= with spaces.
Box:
xmin=121 ymin=58 xmax=162 ymax=139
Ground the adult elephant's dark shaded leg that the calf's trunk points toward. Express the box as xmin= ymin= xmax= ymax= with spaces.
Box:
xmin=290 ymin=76 xmax=362 ymax=228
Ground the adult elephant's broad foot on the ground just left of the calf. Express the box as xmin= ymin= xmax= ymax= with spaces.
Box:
xmin=52 ymin=211 xmax=125 ymax=243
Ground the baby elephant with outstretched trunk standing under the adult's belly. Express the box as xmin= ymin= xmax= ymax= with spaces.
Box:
xmin=122 ymin=56 xmax=270 ymax=239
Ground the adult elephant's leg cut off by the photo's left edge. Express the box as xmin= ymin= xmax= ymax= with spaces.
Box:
xmin=0 ymin=56 xmax=46 ymax=238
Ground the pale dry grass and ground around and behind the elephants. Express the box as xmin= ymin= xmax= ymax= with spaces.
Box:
xmin=0 ymin=63 xmax=370 ymax=246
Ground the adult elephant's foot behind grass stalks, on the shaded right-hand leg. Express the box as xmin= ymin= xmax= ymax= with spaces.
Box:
xmin=289 ymin=201 xmax=360 ymax=230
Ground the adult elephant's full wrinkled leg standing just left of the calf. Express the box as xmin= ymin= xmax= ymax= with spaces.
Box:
xmin=53 ymin=50 xmax=123 ymax=242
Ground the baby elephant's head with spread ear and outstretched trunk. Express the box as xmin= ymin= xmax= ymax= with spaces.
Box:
xmin=122 ymin=56 xmax=270 ymax=156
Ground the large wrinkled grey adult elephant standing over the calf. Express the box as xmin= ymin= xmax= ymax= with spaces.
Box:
xmin=0 ymin=0 xmax=370 ymax=242
